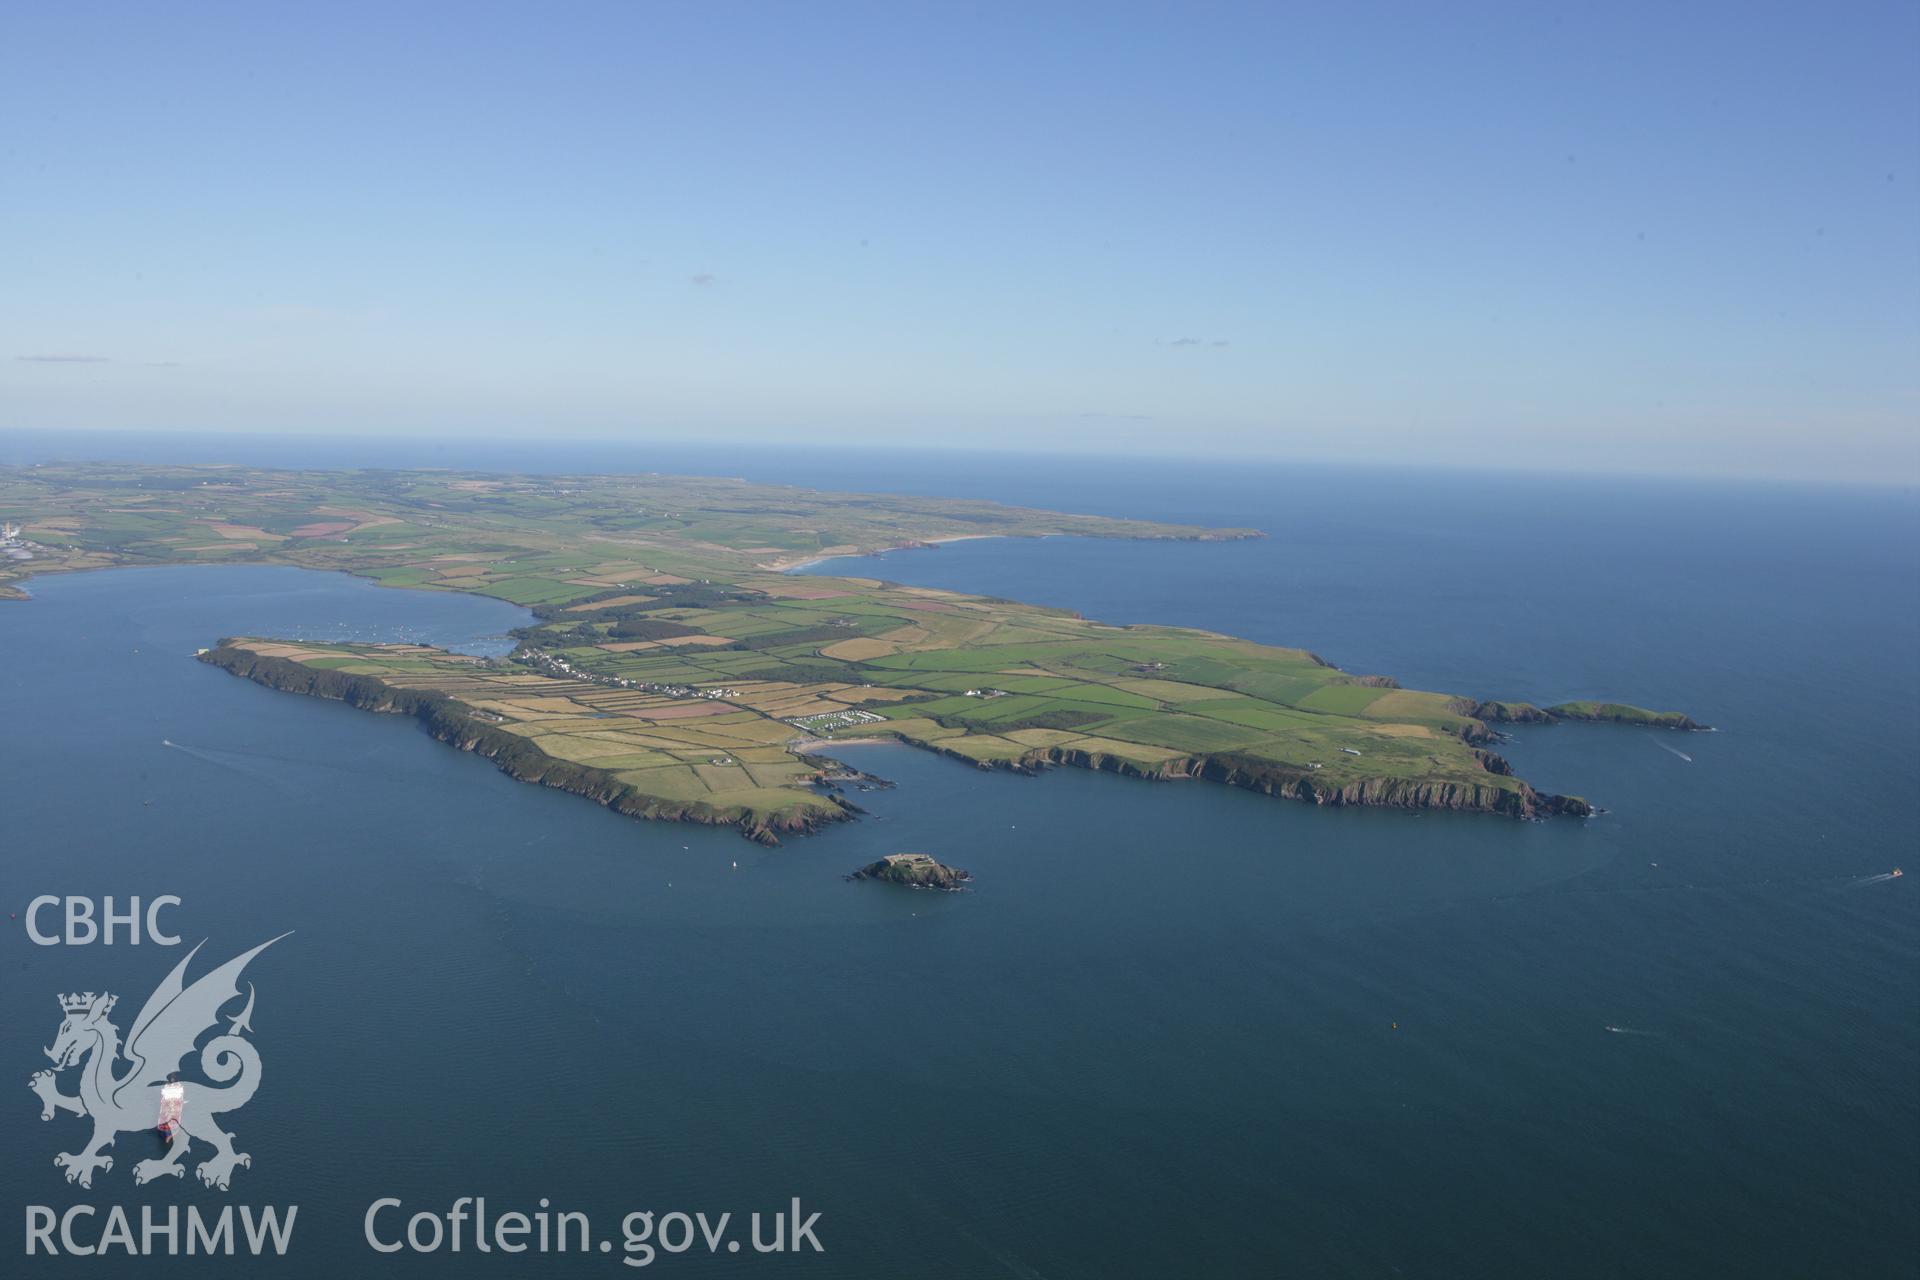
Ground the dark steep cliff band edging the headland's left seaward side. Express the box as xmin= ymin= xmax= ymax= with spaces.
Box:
xmin=200 ymin=641 xmax=858 ymax=844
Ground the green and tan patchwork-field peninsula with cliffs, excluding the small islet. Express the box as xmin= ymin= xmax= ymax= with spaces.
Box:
xmin=0 ymin=464 xmax=1703 ymax=842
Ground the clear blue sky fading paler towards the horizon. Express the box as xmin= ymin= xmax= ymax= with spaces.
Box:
xmin=0 ymin=0 xmax=1920 ymax=482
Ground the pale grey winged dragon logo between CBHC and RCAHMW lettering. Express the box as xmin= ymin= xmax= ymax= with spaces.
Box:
xmin=27 ymin=933 xmax=286 ymax=1192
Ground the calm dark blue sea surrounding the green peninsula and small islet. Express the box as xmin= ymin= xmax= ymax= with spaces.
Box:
xmin=0 ymin=434 xmax=1920 ymax=1278
